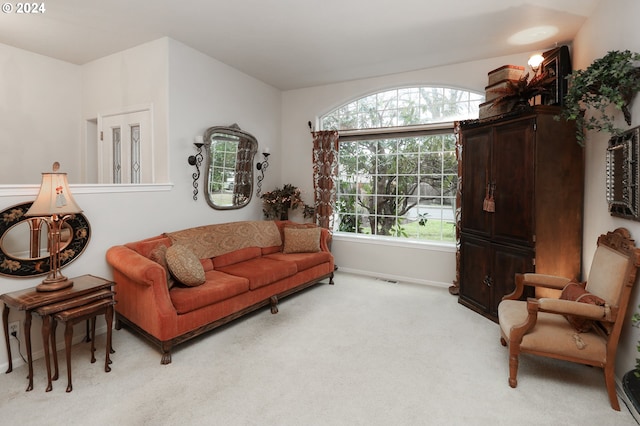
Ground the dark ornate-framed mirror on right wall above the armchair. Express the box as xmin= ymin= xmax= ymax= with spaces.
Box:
xmin=606 ymin=127 xmax=640 ymax=220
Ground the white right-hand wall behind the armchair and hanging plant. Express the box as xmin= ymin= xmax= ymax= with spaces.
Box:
xmin=573 ymin=0 xmax=640 ymax=378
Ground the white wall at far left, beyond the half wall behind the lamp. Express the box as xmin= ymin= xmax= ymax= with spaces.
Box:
xmin=0 ymin=44 xmax=82 ymax=185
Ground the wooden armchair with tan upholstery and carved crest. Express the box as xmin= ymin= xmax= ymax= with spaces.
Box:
xmin=498 ymin=228 xmax=640 ymax=411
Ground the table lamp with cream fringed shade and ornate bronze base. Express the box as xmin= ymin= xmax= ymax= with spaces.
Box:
xmin=25 ymin=161 xmax=82 ymax=291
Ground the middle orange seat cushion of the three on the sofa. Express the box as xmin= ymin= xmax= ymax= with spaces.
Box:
xmin=216 ymin=257 xmax=298 ymax=290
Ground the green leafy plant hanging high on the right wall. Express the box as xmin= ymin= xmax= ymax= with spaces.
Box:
xmin=560 ymin=50 xmax=640 ymax=145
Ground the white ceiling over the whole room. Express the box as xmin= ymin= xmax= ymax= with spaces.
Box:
xmin=0 ymin=0 xmax=600 ymax=90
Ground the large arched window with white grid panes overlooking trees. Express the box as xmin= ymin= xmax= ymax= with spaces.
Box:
xmin=320 ymin=87 xmax=484 ymax=243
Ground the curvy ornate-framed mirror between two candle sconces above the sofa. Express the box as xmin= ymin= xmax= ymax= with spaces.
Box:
xmin=204 ymin=124 xmax=258 ymax=210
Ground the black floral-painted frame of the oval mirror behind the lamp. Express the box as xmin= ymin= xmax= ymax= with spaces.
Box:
xmin=0 ymin=201 xmax=91 ymax=278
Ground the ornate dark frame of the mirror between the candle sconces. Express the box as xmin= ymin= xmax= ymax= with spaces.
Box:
xmin=204 ymin=124 xmax=258 ymax=210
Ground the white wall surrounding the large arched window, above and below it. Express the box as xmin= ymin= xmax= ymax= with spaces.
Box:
xmin=281 ymin=53 xmax=530 ymax=286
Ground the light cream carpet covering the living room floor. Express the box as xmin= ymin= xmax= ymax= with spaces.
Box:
xmin=0 ymin=272 xmax=636 ymax=425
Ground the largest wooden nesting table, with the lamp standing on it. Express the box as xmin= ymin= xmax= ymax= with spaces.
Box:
xmin=0 ymin=275 xmax=115 ymax=391
